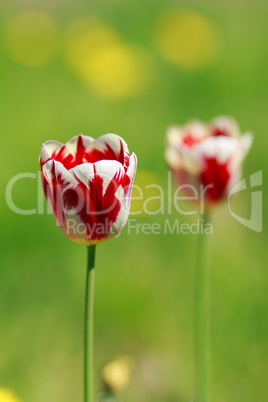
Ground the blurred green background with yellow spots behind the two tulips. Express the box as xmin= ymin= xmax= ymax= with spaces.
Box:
xmin=0 ymin=0 xmax=268 ymax=402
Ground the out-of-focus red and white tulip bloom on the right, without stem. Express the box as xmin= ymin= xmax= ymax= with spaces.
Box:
xmin=165 ymin=117 xmax=252 ymax=206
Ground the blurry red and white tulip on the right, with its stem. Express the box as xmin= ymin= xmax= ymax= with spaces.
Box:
xmin=165 ymin=117 xmax=252 ymax=402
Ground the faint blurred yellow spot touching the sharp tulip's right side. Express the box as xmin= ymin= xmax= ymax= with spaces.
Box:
xmin=130 ymin=170 xmax=165 ymax=216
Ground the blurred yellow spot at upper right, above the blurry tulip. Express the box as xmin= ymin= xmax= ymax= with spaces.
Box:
xmin=155 ymin=9 xmax=220 ymax=69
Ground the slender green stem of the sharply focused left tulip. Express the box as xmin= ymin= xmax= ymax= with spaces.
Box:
xmin=84 ymin=245 xmax=96 ymax=402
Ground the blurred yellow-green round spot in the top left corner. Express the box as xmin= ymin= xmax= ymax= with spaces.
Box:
xmin=6 ymin=10 xmax=58 ymax=66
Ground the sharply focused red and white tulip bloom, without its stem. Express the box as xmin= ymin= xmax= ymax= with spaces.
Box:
xmin=40 ymin=134 xmax=137 ymax=245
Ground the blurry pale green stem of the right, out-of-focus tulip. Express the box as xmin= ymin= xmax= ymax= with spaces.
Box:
xmin=195 ymin=211 xmax=210 ymax=402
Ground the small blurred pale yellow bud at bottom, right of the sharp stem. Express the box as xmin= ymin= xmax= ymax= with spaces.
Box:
xmin=102 ymin=356 xmax=133 ymax=392
